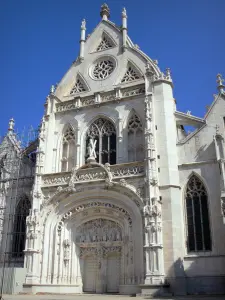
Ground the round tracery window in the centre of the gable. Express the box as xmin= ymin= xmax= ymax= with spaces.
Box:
xmin=91 ymin=58 xmax=114 ymax=80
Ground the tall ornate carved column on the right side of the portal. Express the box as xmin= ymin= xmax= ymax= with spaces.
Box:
xmin=144 ymin=68 xmax=164 ymax=284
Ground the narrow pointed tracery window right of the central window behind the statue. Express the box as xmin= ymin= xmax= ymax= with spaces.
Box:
xmin=128 ymin=113 xmax=144 ymax=161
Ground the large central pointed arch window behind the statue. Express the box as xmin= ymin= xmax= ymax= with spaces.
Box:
xmin=86 ymin=118 xmax=116 ymax=165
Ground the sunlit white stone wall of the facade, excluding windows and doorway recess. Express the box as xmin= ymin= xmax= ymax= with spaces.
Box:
xmin=18 ymin=7 xmax=225 ymax=294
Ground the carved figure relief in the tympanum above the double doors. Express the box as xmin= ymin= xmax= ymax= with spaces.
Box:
xmin=76 ymin=219 xmax=122 ymax=243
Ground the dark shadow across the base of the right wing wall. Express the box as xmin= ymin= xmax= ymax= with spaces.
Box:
xmin=166 ymin=257 xmax=225 ymax=296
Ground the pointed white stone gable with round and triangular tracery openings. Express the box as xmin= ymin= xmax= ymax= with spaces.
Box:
xmin=55 ymin=20 xmax=160 ymax=101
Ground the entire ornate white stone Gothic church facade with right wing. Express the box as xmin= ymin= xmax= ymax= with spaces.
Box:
xmin=0 ymin=4 xmax=225 ymax=294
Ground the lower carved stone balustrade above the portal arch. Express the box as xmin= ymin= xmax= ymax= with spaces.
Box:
xmin=42 ymin=162 xmax=144 ymax=187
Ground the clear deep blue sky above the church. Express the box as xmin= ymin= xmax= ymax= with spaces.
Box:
xmin=0 ymin=0 xmax=225 ymax=135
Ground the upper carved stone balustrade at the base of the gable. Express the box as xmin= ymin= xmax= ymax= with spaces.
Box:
xmin=56 ymin=84 xmax=145 ymax=112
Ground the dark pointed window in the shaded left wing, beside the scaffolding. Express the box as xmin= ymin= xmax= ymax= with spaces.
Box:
xmin=12 ymin=196 xmax=31 ymax=258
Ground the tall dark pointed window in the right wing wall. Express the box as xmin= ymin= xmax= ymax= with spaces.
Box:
xmin=185 ymin=175 xmax=212 ymax=252
